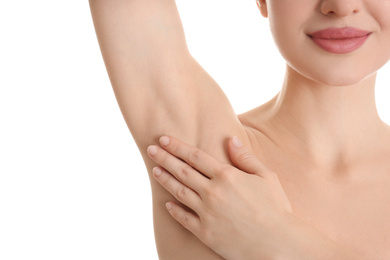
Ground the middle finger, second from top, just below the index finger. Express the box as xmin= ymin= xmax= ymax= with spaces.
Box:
xmin=147 ymin=145 xmax=208 ymax=195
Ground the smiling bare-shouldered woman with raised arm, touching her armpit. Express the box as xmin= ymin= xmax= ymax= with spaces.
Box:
xmin=90 ymin=0 xmax=390 ymax=259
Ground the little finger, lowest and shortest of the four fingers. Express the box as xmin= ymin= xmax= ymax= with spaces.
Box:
xmin=166 ymin=202 xmax=201 ymax=236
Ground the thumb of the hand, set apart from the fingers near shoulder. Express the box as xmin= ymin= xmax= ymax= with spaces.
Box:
xmin=228 ymin=136 xmax=268 ymax=177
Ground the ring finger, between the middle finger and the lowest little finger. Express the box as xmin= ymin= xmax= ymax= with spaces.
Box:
xmin=153 ymin=167 xmax=202 ymax=212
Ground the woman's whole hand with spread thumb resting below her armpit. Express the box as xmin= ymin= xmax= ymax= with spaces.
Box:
xmin=148 ymin=136 xmax=292 ymax=260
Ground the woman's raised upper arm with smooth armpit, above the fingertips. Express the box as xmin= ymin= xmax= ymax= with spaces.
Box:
xmin=90 ymin=0 xmax=245 ymax=152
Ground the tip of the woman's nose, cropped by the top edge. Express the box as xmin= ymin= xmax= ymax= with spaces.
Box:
xmin=321 ymin=0 xmax=360 ymax=17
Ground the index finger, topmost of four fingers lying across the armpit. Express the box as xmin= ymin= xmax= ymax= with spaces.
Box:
xmin=160 ymin=136 xmax=222 ymax=178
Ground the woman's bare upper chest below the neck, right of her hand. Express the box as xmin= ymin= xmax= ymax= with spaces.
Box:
xmin=242 ymin=124 xmax=390 ymax=260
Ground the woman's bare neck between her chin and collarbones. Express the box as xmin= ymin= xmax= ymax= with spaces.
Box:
xmin=269 ymin=67 xmax=386 ymax=170
